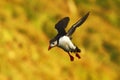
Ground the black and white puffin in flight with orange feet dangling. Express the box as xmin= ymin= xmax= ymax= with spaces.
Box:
xmin=48 ymin=12 xmax=89 ymax=61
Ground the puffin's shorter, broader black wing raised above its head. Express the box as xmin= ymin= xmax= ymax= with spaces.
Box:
xmin=55 ymin=17 xmax=70 ymax=35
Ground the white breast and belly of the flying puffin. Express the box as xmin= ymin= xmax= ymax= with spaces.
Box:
xmin=58 ymin=36 xmax=76 ymax=51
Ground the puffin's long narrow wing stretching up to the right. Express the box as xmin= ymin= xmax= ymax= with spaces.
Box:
xmin=66 ymin=12 xmax=89 ymax=36
